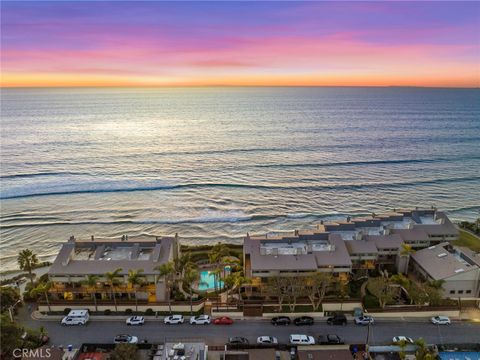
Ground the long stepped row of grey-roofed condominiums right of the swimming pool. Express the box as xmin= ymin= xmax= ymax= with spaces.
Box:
xmin=244 ymin=209 xmax=458 ymax=278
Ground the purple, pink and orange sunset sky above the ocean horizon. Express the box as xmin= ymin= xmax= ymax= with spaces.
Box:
xmin=1 ymin=1 xmax=480 ymax=87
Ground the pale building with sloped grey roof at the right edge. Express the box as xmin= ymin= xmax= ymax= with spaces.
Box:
xmin=410 ymin=242 xmax=480 ymax=298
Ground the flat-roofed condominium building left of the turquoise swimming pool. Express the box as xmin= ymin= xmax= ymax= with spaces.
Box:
xmin=48 ymin=235 xmax=179 ymax=302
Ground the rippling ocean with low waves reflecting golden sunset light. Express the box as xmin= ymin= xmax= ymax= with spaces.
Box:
xmin=0 ymin=88 xmax=480 ymax=269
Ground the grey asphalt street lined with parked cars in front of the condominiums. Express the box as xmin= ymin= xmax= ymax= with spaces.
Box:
xmin=18 ymin=318 xmax=480 ymax=346
